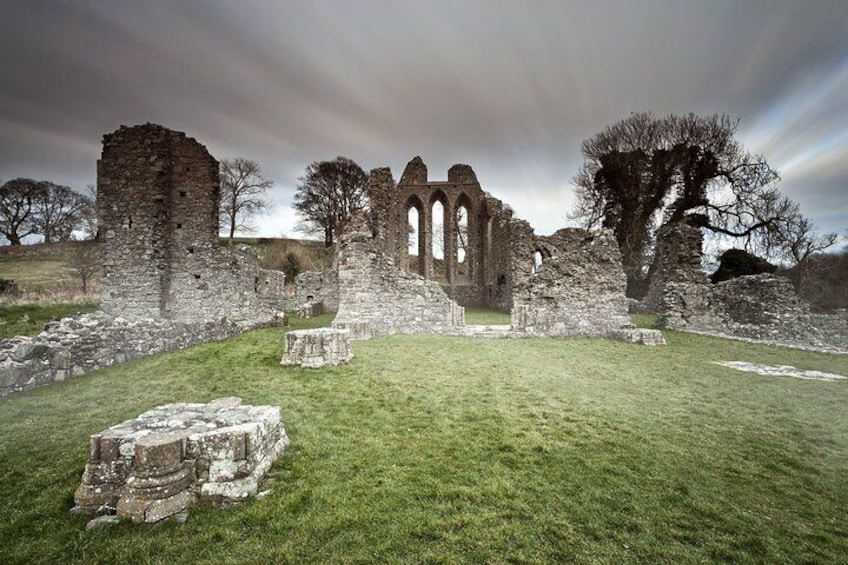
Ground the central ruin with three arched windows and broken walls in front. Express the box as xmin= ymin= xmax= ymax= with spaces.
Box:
xmin=333 ymin=157 xmax=644 ymax=338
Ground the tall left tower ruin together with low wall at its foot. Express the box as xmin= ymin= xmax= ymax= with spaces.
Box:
xmin=0 ymin=124 xmax=286 ymax=397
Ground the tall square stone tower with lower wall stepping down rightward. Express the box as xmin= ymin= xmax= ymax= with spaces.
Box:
xmin=97 ymin=124 xmax=284 ymax=320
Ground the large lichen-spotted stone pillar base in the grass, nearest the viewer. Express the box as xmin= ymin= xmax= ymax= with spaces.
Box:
xmin=72 ymin=397 xmax=289 ymax=523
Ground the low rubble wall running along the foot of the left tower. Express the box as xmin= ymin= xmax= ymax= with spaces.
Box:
xmin=0 ymin=313 xmax=285 ymax=398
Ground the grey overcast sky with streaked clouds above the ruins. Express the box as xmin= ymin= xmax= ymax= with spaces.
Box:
xmin=0 ymin=0 xmax=848 ymax=236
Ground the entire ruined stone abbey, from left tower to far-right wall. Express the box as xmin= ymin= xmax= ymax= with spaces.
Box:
xmin=0 ymin=120 xmax=848 ymax=397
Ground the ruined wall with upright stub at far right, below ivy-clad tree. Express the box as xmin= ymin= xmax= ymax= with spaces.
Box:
xmin=640 ymin=221 xmax=848 ymax=351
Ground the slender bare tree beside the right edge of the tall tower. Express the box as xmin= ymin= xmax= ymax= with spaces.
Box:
xmin=220 ymin=157 xmax=274 ymax=244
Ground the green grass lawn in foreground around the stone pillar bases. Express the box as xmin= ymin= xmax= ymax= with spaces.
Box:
xmin=0 ymin=316 xmax=848 ymax=564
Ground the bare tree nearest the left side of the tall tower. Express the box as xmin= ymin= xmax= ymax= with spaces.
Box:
xmin=30 ymin=181 xmax=94 ymax=243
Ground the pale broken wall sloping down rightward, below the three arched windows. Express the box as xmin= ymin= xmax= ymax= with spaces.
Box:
xmin=333 ymin=207 xmax=464 ymax=335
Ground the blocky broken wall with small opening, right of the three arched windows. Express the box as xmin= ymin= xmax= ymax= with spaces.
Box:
xmin=512 ymin=227 xmax=632 ymax=336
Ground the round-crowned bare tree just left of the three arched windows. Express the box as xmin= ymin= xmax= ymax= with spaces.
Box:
xmin=294 ymin=156 xmax=368 ymax=247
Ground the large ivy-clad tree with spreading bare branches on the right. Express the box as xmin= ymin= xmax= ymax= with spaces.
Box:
xmin=571 ymin=113 xmax=792 ymax=296
